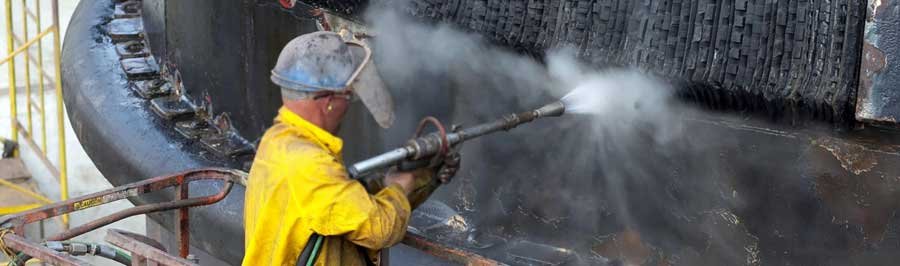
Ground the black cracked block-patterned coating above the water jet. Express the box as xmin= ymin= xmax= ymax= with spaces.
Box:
xmin=306 ymin=0 xmax=866 ymax=126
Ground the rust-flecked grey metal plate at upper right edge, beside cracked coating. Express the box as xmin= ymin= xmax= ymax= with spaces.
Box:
xmin=856 ymin=0 xmax=900 ymax=124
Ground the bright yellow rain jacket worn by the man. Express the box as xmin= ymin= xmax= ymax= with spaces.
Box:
xmin=243 ymin=108 xmax=411 ymax=265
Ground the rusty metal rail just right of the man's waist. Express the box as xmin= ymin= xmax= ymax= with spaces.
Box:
xmin=403 ymin=232 xmax=506 ymax=266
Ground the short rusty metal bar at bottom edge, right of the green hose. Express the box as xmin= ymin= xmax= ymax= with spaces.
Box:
xmin=105 ymin=229 xmax=197 ymax=266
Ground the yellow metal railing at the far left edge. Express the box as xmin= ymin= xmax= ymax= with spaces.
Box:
xmin=0 ymin=0 xmax=69 ymax=228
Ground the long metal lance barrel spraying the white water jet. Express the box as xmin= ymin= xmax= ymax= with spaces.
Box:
xmin=348 ymin=101 xmax=566 ymax=178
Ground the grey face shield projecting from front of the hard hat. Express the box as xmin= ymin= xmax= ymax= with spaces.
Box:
xmin=350 ymin=45 xmax=394 ymax=128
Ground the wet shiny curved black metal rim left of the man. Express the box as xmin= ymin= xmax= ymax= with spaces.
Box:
xmin=62 ymin=1 xmax=250 ymax=261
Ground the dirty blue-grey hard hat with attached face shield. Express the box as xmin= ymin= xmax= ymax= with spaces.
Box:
xmin=272 ymin=31 xmax=394 ymax=128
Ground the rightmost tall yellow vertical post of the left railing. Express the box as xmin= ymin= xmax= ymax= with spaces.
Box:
xmin=51 ymin=0 xmax=69 ymax=229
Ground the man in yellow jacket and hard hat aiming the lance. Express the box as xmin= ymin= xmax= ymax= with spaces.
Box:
xmin=243 ymin=32 xmax=459 ymax=265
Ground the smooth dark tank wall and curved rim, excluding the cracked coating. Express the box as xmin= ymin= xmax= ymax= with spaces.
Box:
xmin=63 ymin=0 xmax=900 ymax=265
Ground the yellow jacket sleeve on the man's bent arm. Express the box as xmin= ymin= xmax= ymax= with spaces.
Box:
xmin=289 ymin=149 xmax=411 ymax=250
